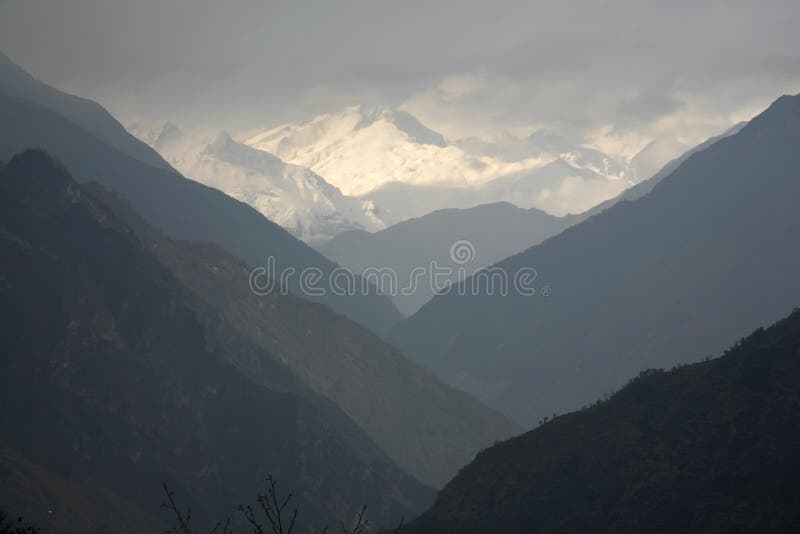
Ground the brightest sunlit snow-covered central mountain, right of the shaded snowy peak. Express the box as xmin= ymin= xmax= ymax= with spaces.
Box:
xmin=246 ymin=106 xmax=633 ymax=223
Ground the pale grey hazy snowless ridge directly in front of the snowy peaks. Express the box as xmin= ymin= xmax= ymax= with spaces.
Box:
xmin=317 ymin=122 xmax=746 ymax=316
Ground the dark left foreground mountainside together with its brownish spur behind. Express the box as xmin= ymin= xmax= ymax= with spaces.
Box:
xmin=0 ymin=151 xmax=515 ymax=532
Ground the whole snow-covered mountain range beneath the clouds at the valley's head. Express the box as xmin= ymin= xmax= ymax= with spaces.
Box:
xmin=128 ymin=101 xmax=708 ymax=246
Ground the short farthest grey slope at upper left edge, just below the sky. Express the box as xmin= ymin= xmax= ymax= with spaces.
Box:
xmin=0 ymin=52 xmax=170 ymax=169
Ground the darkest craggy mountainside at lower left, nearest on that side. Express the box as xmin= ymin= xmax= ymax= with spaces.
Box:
xmin=0 ymin=152 xmax=428 ymax=533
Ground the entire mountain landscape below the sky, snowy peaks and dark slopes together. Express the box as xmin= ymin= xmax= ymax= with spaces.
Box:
xmin=0 ymin=45 xmax=800 ymax=534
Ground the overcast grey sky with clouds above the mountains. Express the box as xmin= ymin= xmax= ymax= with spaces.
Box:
xmin=0 ymin=0 xmax=800 ymax=153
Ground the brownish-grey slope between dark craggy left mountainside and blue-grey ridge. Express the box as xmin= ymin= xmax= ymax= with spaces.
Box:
xmin=96 ymin=177 xmax=517 ymax=494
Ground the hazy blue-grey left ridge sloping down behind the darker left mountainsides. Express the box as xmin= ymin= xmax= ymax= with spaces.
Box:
xmin=0 ymin=53 xmax=401 ymax=332
